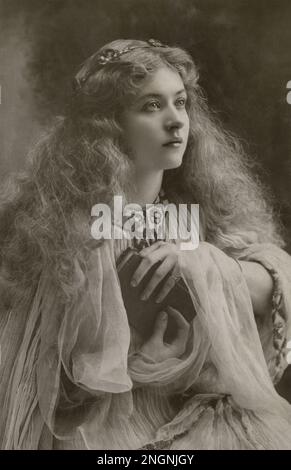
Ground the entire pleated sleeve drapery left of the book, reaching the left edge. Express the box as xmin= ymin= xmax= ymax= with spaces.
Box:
xmin=0 ymin=242 xmax=132 ymax=449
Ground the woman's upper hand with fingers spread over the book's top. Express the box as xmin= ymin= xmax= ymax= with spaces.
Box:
xmin=131 ymin=241 xmax=180 ymax=302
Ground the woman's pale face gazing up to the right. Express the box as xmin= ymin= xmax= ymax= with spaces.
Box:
xmin=122 ymin=66 xmax=189 ymax=171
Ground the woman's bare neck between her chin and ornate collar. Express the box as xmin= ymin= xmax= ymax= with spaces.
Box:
xmin=134 ymin=170 xmax=164 ymax=206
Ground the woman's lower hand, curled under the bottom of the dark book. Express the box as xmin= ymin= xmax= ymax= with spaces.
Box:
xmin=140 ymin=307 xmax=190 ymax=362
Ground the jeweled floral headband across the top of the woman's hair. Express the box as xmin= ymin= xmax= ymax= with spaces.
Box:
xmin=74 ymin=39 xmax=169 ymax=91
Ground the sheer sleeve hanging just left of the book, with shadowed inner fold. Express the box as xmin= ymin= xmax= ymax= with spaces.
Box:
xmin=37 ymin=242 xmax=132 ymax=438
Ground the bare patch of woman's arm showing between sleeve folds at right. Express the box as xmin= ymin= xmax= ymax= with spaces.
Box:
xmin=239 ymin=261 xmax=273 ymax=317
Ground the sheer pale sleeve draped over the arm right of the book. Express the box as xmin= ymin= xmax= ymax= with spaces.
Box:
xmin=176 ymin=242 xmax=291 ymax=414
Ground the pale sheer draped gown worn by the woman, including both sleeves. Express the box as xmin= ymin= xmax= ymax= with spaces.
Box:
xmin=0 ymin=216 xmax=291 ymax=449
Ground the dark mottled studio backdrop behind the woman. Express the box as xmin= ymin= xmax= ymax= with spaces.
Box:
xmin=0 ymin=0 xmax=291 ymax=401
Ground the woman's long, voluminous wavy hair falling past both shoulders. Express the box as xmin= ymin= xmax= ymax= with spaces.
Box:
xmin=0 ymin=40 xmax=283 ymax=298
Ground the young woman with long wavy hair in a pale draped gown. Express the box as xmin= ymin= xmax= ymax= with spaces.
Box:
xmin=0 ymin=40 xmax=291 ymax=449
